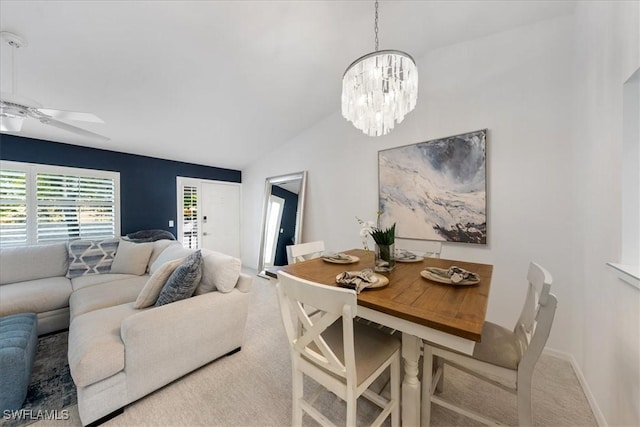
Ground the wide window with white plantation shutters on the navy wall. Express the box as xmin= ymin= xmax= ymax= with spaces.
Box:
xmin=0 ymin=162 xmax=120 ymax=246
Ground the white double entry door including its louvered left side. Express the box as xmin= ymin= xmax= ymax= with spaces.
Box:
xmin=177 ymin=177 xmax=241 ymax=258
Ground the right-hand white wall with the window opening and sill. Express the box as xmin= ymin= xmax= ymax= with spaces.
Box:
xmin=571 ymin=2 xmax=640 ymax=426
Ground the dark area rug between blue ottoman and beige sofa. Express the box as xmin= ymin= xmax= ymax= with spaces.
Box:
xmin=0 ymin=331 xmax=77 ymax=427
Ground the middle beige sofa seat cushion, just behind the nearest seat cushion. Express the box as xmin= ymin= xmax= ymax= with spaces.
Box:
xmin=69 ymin=276 xmax=149 ymax=321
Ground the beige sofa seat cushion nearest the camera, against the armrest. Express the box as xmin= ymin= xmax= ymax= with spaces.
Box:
xmin=68 ymin=303 xmax=136 ymax=387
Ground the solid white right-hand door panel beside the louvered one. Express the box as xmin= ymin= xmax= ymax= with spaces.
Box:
xmin=201 ymin=182 xmax=240 ymax=258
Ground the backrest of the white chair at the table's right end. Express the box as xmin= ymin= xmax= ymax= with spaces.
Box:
xmin=513 ymin=262 xmax=558 ymax=368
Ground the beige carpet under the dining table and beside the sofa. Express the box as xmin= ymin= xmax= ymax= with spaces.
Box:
xmin=33 ymin=277 xmax=597 ymax=427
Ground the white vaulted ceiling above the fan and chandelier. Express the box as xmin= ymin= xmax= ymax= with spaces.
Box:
xmin=0 ymin=0 xmax=575 ymax=169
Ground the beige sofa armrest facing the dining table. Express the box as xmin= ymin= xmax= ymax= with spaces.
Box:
xmin=120 ymin=289 xmax=250 ymax=401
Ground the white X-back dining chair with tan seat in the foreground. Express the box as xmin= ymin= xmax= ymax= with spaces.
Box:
xmin=276 ymin=272 xmax=401 ymax=427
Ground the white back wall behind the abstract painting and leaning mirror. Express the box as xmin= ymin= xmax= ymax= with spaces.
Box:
xmin=242 ymin=17 xmax=573 ymax=350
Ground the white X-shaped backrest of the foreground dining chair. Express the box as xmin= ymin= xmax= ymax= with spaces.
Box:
xmin=276 ymin=272 xmax=357 ymax=381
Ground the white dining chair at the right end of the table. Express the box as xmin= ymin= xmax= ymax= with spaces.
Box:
xmin=422 ymin=262 xmax=558 ymax=426
